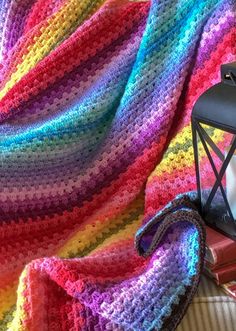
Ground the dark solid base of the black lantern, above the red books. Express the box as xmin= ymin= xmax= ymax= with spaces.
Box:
xmin=202 ymin=207 xmax=236 ymax=241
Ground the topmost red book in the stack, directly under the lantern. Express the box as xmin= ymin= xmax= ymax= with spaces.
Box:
xmin=205 ymin=226 xmax=236 ymax=268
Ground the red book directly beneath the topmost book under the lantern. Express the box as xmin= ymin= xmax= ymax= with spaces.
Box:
xmin=204 ymin=263 xmax=236 ymax=285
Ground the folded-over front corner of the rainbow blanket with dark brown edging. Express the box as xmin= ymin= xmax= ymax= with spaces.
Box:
xmin=12 ymin=196 xmax=205 ymax=331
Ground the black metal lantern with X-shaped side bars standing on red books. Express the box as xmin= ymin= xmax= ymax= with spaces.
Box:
xmin=192 ymin=62 xmax=236 ymax=240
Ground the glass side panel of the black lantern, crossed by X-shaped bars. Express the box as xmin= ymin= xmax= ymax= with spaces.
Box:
xmin=197 ymin=123 xmax=236 ymax=231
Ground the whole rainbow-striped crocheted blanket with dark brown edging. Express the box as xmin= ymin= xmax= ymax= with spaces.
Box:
xmin=0 ymin=0 xmax=235 ymax=331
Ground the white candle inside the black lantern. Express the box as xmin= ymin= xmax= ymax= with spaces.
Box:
xmin=225 ymin=151 xmax=236 ymax=220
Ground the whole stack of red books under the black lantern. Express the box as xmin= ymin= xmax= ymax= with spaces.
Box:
xmin=204 ymin=226 xmax=236 ymax=299
